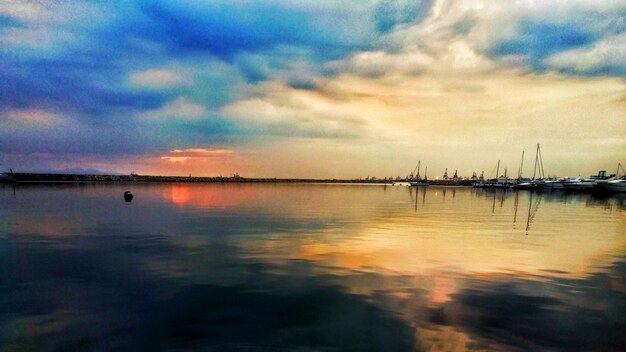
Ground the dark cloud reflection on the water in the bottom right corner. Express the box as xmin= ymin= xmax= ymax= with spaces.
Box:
xmin=437 ymin=262 xmax=626 ymax=351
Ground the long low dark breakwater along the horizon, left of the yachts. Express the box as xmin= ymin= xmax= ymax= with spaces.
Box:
xmin=1 ymin=173 xmax=473 ymax=186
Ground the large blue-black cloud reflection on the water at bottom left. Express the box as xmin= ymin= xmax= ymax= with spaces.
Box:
xmin=0 ymin=238 xmax=415 ymax=351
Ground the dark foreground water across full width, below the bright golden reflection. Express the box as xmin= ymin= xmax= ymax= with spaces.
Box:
xmin=0 ymin=230 xmax=626 ymax=351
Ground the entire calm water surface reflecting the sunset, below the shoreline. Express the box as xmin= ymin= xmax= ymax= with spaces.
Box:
xmin=0 ymin=184 xmax=626 ymax=351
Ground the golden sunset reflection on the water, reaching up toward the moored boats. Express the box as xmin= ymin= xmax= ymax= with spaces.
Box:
xmin=242 ymin=189 xmax=626 ymax=277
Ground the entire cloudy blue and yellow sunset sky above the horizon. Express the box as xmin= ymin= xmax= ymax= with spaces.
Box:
xmin=0 ymin=0 xmax=626 ymax=178
